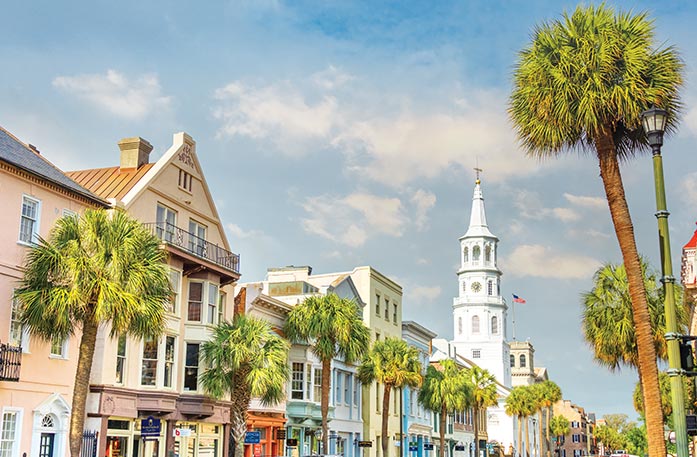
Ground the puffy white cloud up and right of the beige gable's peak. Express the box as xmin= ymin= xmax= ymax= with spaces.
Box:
xmin=213 ymin=81 xmax=338 ymax=157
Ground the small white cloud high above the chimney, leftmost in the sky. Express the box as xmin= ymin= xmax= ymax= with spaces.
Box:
xmin=53 ymin=70 xmax=170 ymax=119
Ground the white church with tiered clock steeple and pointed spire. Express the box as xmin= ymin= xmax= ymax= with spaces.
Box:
xmin=451 ymin=179 xmax=517 ymax=452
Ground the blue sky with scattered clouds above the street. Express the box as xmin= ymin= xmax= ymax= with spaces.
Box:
xmin=0 ymin=0 xmax=697 ymax=420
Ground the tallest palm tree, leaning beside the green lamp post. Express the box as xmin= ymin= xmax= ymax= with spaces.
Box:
xmin=509 ymin=4 xmax=683 ymax=456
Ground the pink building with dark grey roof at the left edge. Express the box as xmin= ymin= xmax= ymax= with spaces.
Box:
xmin=0 ymin=127 xmax=106 ymax=457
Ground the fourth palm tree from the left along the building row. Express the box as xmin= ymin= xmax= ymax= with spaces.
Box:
xmin=358 ymin=337 xmax=423 ymax=457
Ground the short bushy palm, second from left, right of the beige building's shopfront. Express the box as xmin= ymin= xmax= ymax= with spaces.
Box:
xmin=201 ymin=314 xmax=290 ymax=457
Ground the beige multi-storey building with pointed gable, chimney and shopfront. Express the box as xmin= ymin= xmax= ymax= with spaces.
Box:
xmin=68 ymin=133 xmax=240 ymax=457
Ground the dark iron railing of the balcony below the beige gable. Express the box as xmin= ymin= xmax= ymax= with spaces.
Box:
xmin=144 ymin=222 xmax=240 ymax=274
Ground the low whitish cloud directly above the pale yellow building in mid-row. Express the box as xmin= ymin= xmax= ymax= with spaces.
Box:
xmin=302 ymin=192 xmax=407 ymax=247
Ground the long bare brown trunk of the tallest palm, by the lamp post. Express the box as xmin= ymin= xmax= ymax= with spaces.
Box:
xmin=596 ymin=132 xmax=666 ymax=456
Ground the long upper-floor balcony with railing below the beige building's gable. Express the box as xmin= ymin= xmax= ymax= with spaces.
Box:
xmin=143 ymin=222 xmax=240 ymax=284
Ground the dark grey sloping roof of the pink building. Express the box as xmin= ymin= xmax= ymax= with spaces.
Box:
xmin=0 ymin=127 xmax=105 ymax=205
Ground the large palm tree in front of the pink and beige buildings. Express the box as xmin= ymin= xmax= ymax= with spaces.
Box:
xmin=15 ymin=210 xmax=171 ymax=457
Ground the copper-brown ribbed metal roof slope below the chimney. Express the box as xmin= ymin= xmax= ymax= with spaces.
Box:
xmin=66 ymin=163 xmax=154 ymax=200
